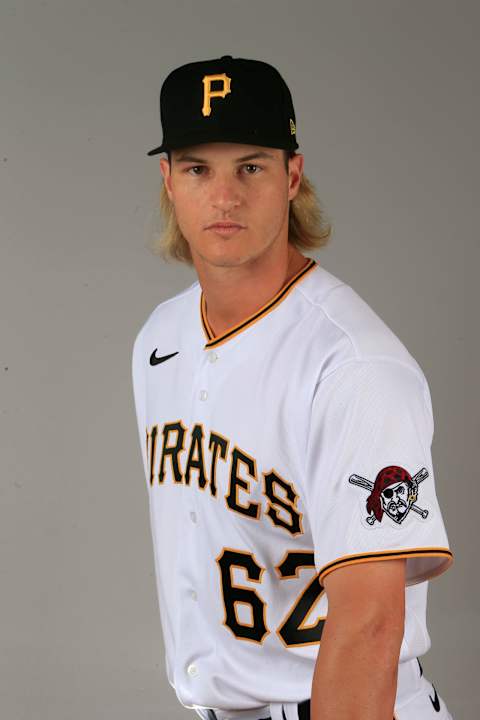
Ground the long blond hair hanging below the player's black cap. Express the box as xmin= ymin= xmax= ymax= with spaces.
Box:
xmin=148 ymin=150 xmax=332 ymax=266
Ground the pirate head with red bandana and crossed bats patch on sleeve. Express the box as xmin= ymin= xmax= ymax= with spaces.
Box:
xmin=348 ymin=465 xmax=428 ymax=525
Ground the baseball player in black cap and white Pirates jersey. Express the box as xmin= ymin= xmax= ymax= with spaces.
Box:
xmin=132 ymin=55 xmax=453 ymax=720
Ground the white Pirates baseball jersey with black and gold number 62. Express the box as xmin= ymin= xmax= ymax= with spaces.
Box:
xmin=132 ymin=258 xmax=453 ymax=720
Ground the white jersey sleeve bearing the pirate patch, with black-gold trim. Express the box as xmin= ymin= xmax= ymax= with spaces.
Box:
xmin=303 ymin=359 xmax=453 ymax=585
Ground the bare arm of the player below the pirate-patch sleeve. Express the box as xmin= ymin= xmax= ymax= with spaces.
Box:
xmin=310 ymin=558 xmax=406 ymax=720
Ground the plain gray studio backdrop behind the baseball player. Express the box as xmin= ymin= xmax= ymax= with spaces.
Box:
xmin=0 ymin=0 xmax=480 ymax=720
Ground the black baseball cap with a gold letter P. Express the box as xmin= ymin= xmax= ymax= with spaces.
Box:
xmin=147 ymin=55 xmax=298 ymax=155
